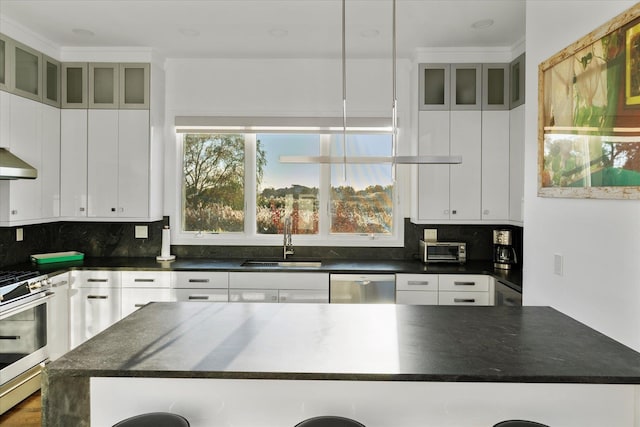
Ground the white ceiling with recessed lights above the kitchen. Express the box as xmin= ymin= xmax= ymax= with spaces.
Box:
xmin=0 ymin=0 xmax=525 ymax=58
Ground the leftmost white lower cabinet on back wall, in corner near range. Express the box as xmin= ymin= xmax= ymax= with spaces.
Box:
xmin=70 ymin=270 xmax=121 ymax=348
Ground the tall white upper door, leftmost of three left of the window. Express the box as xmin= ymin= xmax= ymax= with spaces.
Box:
xmin=60 ymin=109 xmax=87 ymax=218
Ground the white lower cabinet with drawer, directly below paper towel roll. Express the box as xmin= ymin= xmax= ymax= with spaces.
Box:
xmin=121 ymin=271 xmax=175 ymax=317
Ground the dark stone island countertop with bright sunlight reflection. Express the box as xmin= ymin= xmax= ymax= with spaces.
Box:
xmin=47 ymin=302 xmax=640 ymax=384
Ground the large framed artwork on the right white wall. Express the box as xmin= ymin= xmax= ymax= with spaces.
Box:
xmin=538 ymin=3 xmax=640 ymax=199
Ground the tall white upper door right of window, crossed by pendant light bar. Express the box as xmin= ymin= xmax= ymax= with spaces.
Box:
xmin=417 ymin=111 xmax=452 ymax=220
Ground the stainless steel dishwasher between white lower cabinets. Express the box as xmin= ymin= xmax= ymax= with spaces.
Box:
xmin=329 ymin=274 xmax=396 ymax=304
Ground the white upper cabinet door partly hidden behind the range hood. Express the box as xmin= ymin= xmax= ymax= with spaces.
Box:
xmin=0 ymin=95 xmax=42 ymax=222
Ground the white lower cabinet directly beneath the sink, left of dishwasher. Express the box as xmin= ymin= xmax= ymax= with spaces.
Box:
xmin=229 ymin=272 xmax=329 ymax=303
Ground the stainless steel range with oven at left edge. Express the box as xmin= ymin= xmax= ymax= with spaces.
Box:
xmin=0 ymin=271 xmax=53 ymax=414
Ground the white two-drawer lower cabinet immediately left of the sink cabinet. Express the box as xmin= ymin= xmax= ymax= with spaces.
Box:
xmin=172 ymin=271 xmax=229 ymax=302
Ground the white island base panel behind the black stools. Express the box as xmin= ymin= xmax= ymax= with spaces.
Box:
xmin=90 ymin=377 xmax=640 ymax=427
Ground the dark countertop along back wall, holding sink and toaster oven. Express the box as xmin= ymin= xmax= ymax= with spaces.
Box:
xmin=16 ymin=257 xmax=522 ymax=292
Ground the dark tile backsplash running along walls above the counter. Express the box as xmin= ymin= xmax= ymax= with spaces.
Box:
xmin=0 ymin=218 xmax=522 ymax=267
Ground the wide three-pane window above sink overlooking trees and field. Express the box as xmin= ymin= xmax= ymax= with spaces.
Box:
xmin=174 ymin=120 xmax=402 ymax=246
